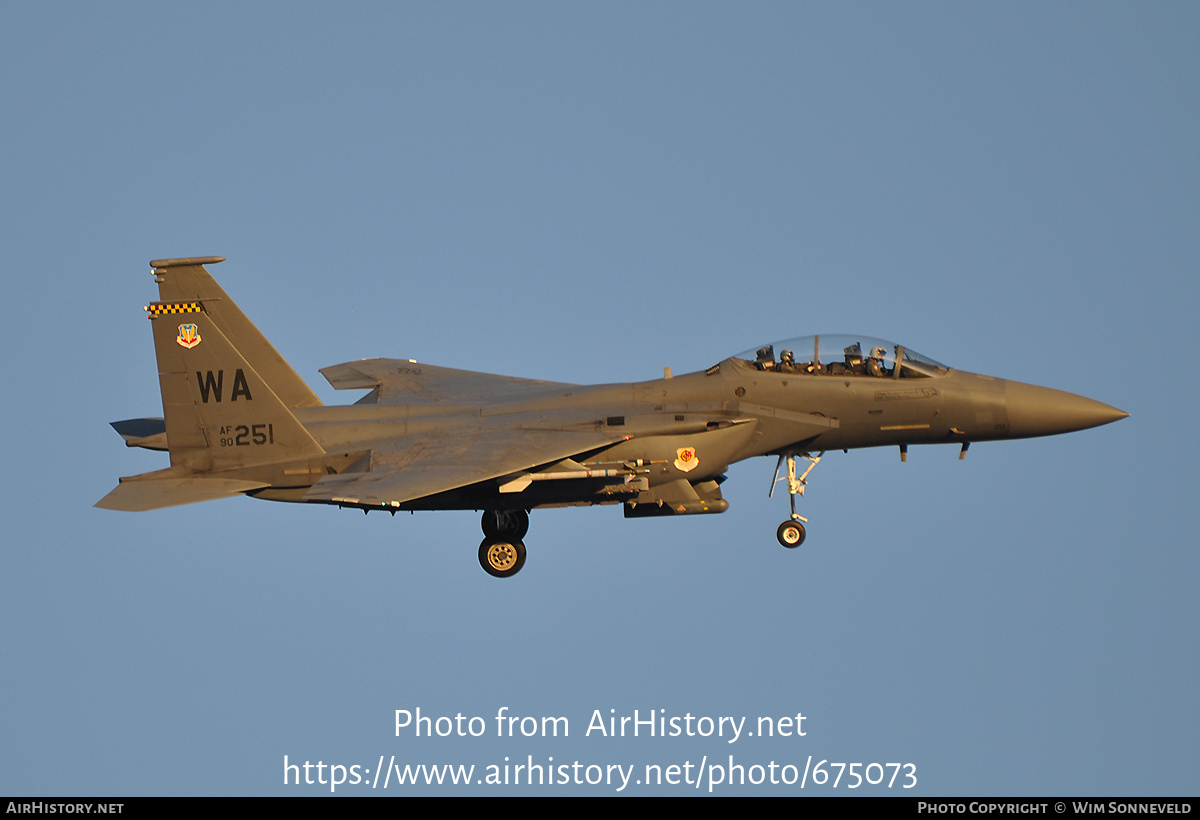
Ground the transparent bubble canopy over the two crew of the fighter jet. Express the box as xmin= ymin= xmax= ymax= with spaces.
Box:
xmin=733 ymin=334 xmax=949 ymax=378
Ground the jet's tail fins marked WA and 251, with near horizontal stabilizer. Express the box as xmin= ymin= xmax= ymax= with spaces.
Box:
xmin=96 ymin=257 xmax=324 ymax=510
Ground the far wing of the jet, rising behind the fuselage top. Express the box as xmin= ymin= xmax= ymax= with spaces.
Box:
xmin=320 ymin=359 xmax=576 ymax=405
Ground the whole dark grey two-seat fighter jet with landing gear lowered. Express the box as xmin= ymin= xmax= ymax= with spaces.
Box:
xmin=96 ymin=257 xmax=1128 ymax=577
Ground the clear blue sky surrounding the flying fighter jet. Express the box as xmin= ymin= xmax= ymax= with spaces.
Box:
xmin=0 ymin=2 xmax=1200 ymax=795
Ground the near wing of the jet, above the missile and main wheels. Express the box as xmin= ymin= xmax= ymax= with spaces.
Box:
xmin=305 ymin=426 xmax=625 ymax=507
